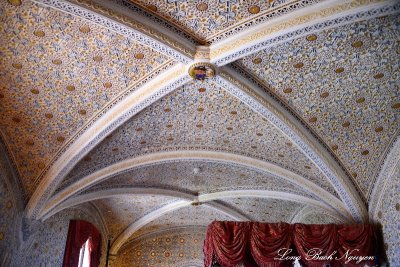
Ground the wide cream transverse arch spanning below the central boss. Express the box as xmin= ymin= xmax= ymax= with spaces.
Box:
xmin=40 ymin=150 xmax=351 ymax=222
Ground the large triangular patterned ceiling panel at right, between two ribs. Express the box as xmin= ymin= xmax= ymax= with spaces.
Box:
xmin=239 ymin=15 xmax=400 ymax=197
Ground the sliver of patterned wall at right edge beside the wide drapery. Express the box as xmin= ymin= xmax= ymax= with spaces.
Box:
xmin=377 ymin=163 xmax=400 ymax=266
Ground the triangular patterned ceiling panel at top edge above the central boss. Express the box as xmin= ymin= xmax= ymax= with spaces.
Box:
xmin=131 ymin=0 xmax=319 ymax=43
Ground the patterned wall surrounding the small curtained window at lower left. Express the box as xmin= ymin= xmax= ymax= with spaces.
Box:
xmin=11 ymin=208 xmax=106 ymax=267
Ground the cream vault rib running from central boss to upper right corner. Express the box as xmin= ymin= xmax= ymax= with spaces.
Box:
xmin=210 ymin=0 xmax=400 ymax=66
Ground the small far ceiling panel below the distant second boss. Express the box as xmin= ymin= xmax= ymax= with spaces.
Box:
xmin=126 ymin=204 xmax=234 ymax=243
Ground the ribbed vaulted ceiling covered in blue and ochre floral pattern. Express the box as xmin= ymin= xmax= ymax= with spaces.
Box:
xmin=0 ymin=0 xmax=400 ymax=264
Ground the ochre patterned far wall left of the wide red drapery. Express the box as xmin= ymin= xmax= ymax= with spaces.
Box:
xmin=112 ymin=228 xmax=205 ymax=267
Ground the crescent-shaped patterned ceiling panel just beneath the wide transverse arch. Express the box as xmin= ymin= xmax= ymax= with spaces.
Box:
xmin=80 ymin=160 xmax=312 ymax=198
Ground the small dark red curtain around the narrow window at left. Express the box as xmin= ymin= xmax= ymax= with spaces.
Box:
xmin=63 ymin=220 xmax=101 ymax=267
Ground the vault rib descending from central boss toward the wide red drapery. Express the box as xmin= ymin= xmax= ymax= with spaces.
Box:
xmin=215 ymin=68 xmax=367 ymax=222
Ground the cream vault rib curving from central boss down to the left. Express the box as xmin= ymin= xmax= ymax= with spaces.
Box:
xmin=25 ymin=64 xmax=191 ymax=219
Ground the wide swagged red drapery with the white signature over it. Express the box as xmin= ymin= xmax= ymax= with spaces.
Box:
xmin=204 ymin=221 xmax=375 ymax=267
